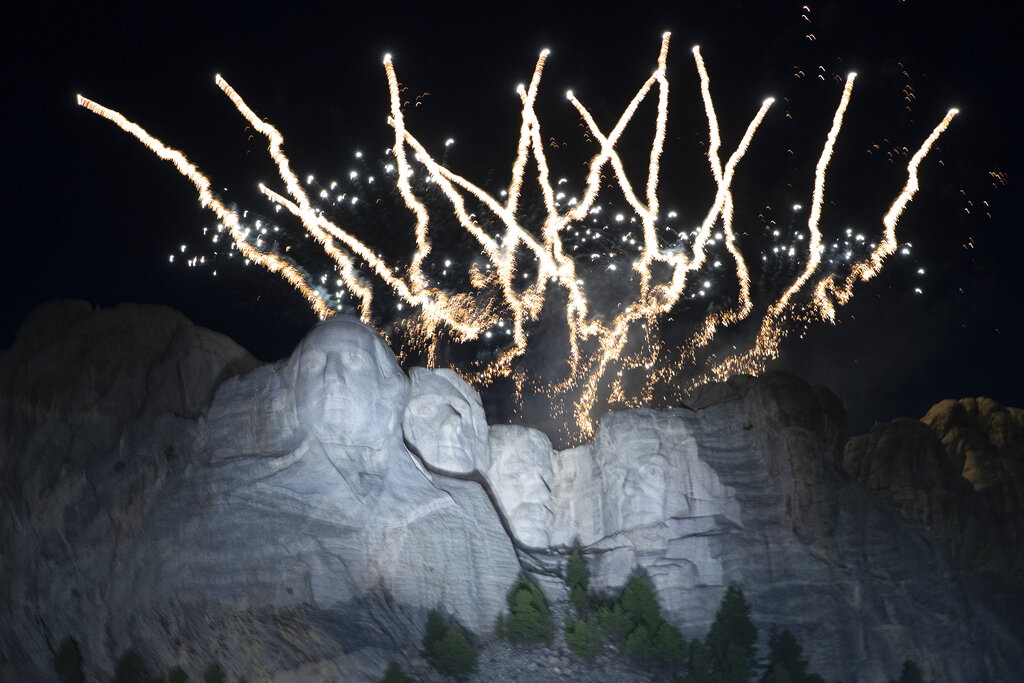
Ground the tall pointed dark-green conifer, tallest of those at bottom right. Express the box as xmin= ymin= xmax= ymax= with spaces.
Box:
xmin=706 ymin=586 xmax=758 ymax=681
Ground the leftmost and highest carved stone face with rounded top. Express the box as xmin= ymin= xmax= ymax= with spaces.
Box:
xmin=291 ymin=318 xmax=409 ymax=449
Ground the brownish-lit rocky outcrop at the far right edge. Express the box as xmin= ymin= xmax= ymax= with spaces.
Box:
xmin=842 ymin=398 xmax=1024 ymax=572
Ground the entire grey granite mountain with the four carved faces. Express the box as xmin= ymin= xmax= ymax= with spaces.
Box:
xmin=0 ymin=302 xmax=1024 ymax=682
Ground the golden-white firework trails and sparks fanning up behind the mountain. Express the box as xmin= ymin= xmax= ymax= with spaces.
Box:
xmin=78 ymin=34 xmax=956 ymax=438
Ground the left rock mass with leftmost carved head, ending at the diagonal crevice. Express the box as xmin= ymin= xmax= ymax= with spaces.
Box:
xmin=0 ymin=307 xmax=520 ymax=680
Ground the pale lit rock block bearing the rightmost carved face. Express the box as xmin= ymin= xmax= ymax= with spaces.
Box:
xmin=553 ymin=410 xmax=739 ymax=593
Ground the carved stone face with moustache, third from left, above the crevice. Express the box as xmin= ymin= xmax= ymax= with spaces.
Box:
xmin=487 ymin=425 xmax=555 ymax=548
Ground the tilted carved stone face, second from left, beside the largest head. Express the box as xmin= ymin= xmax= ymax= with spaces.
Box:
xmin=402 ymin=368 xmax=489 ymax=474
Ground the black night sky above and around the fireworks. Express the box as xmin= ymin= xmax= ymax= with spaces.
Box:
xmin=0 ymin=0 xmax=1024 ymax=438
